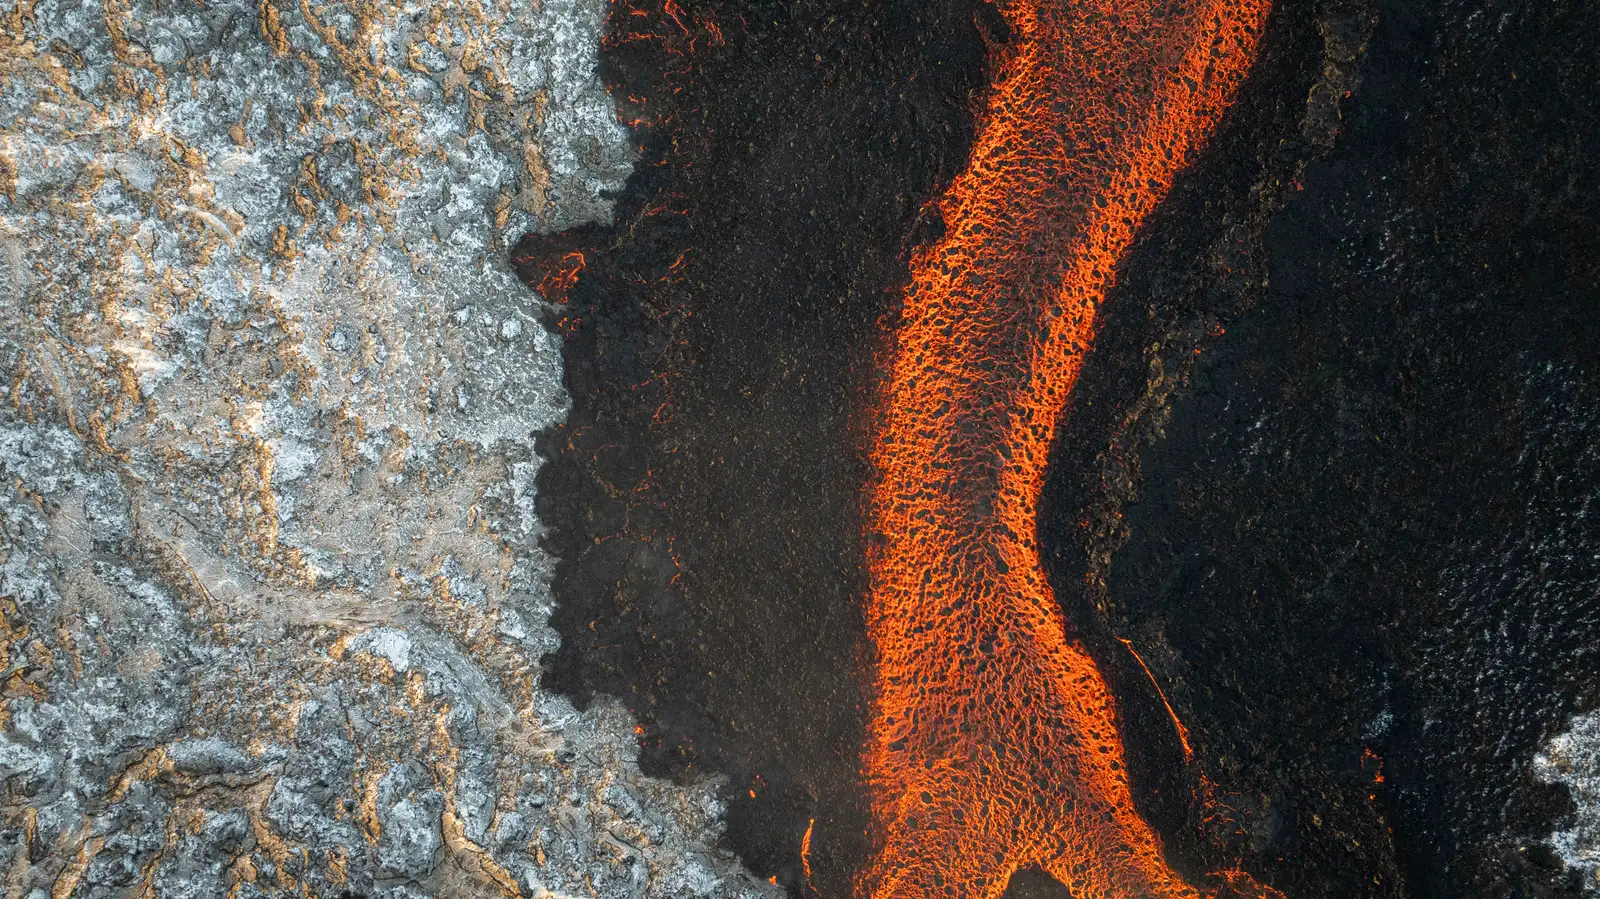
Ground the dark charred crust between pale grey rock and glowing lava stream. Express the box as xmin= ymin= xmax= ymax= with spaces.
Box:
xmin=518 ymin=0 xmax=998 ymax=896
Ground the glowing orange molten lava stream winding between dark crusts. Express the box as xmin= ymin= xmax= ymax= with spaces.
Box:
xmin=859 ymin=0 xmax=1269 ymax=899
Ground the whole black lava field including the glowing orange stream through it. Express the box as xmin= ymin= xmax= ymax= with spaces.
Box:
xmin=514 ymin=0 xmax=1600 ymax=899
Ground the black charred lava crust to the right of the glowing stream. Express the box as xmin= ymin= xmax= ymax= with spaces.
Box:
xmin=1045 ymin=2 xmax=1600 ymax=899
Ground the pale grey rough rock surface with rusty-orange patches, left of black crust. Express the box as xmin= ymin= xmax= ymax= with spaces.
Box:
xmin=0 ymin=0 xmax=766 ymax=899
